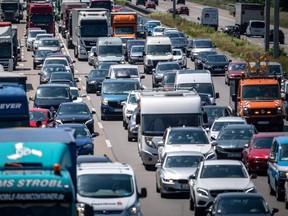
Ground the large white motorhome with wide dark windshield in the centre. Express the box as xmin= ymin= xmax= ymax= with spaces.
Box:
xmin=136 ymin=90 xmax=207 ymax=169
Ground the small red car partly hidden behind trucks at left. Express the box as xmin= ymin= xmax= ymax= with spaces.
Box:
xmin=29 ymin=108 xmax=55 ymax=128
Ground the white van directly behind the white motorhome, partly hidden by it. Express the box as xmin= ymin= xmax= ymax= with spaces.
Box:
xmin=174 ymin=69 xmax=219 ymax=104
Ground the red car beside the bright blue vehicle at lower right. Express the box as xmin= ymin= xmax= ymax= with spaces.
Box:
xmin=242 ymin=133 xmax=281 ymax=173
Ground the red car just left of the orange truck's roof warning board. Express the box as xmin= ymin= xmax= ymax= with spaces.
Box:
xmin=225 ymin=62 xmax=246 ymax=86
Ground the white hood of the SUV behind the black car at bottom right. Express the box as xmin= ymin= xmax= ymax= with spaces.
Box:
xmin=197 ymin=178 xmax=254 ymax=191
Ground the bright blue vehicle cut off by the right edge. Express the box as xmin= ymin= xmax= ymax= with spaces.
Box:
xmin=267 ymin=136 xmax=288 ymax=200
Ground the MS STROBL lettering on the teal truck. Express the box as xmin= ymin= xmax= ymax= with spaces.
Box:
xmin=0 ymin=179 xmax=63 ymax=188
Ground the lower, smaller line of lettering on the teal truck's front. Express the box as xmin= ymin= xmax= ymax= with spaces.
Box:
xmin=0 ymin=193 xmax=65 ymax=201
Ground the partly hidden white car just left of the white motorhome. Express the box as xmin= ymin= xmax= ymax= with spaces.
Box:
xmin=121 ymin=91 xmax=139 ymax=129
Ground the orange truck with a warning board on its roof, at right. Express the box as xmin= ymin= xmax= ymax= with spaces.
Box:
xmin=229 ymin=52 xmax=284 ymax=131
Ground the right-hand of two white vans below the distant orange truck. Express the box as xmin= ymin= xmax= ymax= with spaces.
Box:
xmin=143 ymin=36 xmax=173 ymax=74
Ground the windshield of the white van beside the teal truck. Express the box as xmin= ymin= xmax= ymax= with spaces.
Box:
xmin=77 ymin=174 xmax=134 ymax=198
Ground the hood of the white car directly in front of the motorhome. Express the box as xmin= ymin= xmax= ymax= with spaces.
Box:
xmin=165 ymin=144 xmax=212 ymax=154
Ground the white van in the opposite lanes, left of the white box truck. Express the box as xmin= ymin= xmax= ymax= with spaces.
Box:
xmin=198 ymin=7 xmax=219 ymax=31
